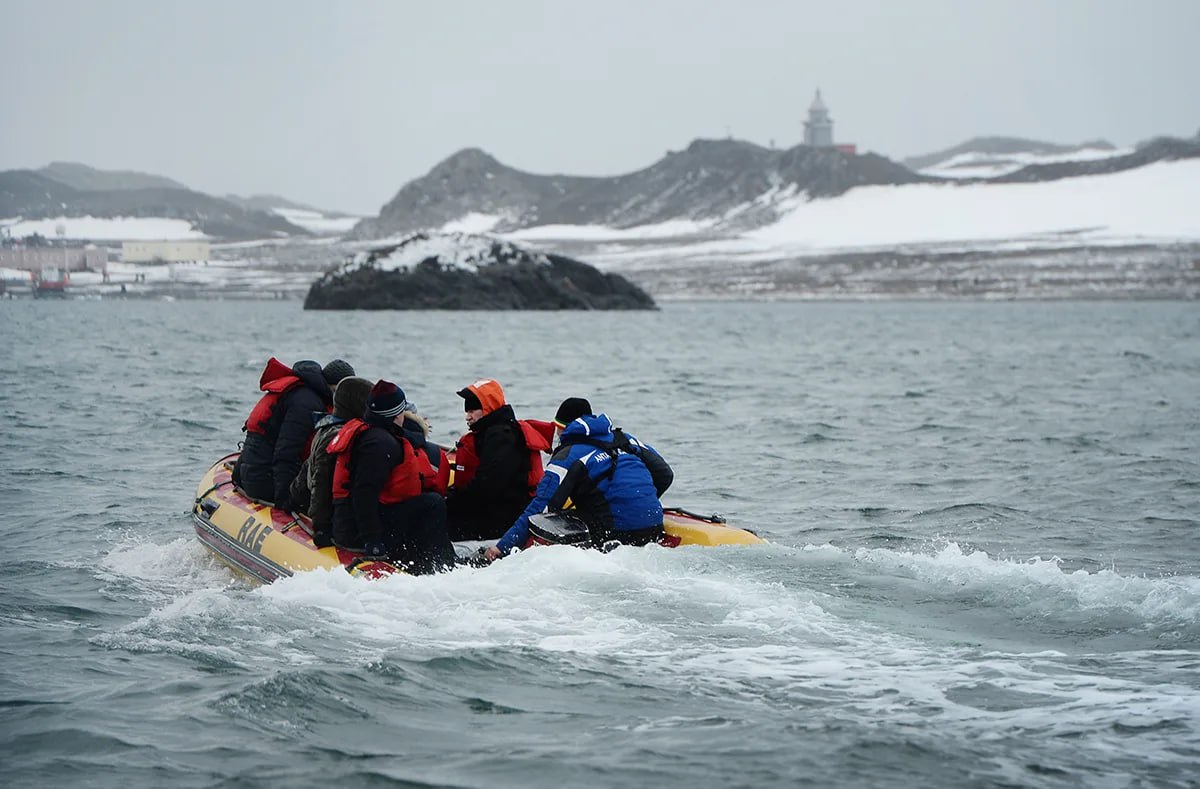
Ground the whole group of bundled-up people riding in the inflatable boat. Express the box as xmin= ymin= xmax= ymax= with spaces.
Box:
xmin=226 ymin=357 xmax=674 ymax=573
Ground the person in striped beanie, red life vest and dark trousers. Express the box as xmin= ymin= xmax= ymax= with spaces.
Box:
xmin=326 ymin=380 xmax=455 ymax=574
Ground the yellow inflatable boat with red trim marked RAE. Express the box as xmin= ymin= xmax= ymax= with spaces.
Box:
xmin=192 ymin=453 xmax=763 ymax=584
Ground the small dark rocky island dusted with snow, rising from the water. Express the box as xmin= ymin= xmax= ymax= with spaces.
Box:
xmin=304 ymin=233 xmax=656 ymax=309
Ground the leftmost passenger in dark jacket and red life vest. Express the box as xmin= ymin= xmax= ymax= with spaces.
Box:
xmin=233 ymin=356 xmax=354 ymax=510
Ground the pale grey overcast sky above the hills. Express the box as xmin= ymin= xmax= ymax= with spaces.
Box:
xmin=0 ymin=0 xmax=1200 ymax=213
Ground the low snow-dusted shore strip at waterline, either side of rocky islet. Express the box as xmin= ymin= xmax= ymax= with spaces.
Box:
xmin=9 ymin=240 xmax=1200 ymax=302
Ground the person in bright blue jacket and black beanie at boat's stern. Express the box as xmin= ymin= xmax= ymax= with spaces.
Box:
xmin=485 ymin=397 xmax=674 ymax=560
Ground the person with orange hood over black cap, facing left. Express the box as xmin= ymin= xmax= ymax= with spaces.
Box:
xmin=446 ymin=378 xmax=554 ymax=540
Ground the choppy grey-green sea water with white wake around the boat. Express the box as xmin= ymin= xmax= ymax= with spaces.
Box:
xmin=0 ymin=301 xmax=1200 ymax=788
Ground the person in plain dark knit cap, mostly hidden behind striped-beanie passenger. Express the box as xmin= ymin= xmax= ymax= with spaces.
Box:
xmin=290 ymin=375 xmax=371 ymax=548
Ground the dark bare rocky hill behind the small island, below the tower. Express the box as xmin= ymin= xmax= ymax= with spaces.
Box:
xmin=354 ymin=139 xmax=931 ymax=239
